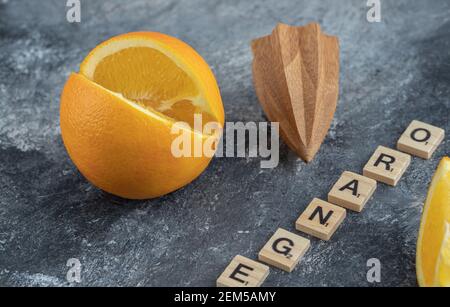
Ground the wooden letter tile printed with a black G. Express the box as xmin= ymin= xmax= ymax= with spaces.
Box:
xmin=258 ymin=228 xmax=310 ymax=272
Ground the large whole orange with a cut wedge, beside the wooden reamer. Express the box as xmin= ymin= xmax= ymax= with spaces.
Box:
xmin=60 ymin=32 xmax=224 ymax=199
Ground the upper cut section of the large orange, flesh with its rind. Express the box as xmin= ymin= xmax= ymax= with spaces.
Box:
xmin=80 ymin=32 xmax=224 ymax=127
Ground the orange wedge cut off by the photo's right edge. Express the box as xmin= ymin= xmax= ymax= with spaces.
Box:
xmin=416 ymin=157 xmax=450 ymax=287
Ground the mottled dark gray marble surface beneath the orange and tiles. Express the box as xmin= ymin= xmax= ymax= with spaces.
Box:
xmin=0 ymin=0 xmax=450 ymax=286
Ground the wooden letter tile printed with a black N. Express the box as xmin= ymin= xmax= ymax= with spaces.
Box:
xmin=295 ymin=198 xmax=346 ymax=241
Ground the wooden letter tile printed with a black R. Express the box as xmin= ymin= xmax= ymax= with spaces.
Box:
xmin=363 ymin=146 xmax=411 ymax=186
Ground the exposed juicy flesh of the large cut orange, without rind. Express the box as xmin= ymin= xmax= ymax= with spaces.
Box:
xmin=93 ymin=47 xmax=217 ymax=128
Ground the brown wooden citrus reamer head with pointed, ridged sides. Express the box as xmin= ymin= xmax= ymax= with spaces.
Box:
xmin=252 ymin=23 xmax=339 ymax=162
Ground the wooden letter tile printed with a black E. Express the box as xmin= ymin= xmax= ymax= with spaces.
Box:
xmin=217 ymin=255 xmax=269 ymax=287
